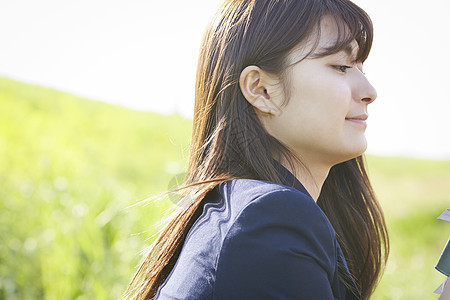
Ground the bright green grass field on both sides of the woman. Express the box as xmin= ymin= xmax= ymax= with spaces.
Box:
xmin=0 ymin=78 xmax=450 ymax=300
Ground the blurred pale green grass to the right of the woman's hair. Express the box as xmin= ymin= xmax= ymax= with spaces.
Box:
xmin=367 ymin=156 xmax=450 ymax=299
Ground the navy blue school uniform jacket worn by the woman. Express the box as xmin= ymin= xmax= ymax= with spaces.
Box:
xmin=155 ymin=161 xmax=361 ymax=300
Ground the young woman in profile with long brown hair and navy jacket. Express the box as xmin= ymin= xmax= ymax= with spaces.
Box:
xmin=126 ymin=0 xmax=389 ymax=299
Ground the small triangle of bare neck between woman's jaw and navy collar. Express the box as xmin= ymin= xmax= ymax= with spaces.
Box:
xmin=281 ymin=157 xmax=331 ymax=202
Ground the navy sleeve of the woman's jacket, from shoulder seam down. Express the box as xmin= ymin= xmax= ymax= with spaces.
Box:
xmin=213 ymin=191 xmax=336 ymax=300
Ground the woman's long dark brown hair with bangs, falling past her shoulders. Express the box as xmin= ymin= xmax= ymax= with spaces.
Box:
xmin=124 ymin=0 xmax=389 ymax=299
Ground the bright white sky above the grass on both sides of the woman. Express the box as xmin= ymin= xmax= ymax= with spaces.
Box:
xmin=0 ymin=0 xmax=450 ymax=158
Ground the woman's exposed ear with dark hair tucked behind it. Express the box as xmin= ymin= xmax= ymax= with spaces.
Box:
xmin=239 ymin=66 xmax=281 ymax=115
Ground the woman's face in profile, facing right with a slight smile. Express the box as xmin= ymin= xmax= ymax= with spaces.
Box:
xmin=262 ymin=17 xmax=376 ymax=165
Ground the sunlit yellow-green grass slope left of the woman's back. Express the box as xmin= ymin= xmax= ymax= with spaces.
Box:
xmin=0 ymin=78 xmax=191 ymax=299
